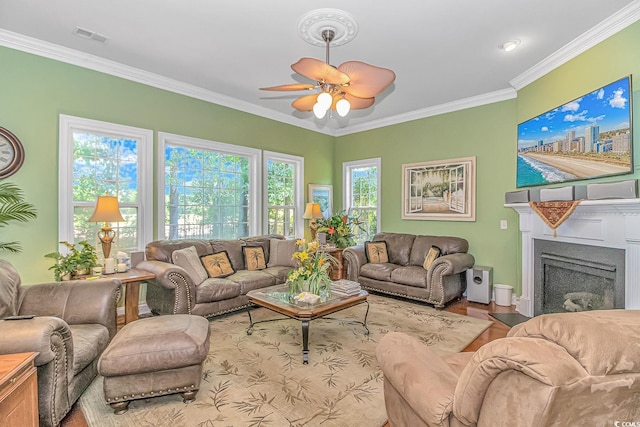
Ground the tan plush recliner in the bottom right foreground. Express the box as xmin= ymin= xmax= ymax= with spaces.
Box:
xmin=377 ymin=310 xmax=640 ymax=427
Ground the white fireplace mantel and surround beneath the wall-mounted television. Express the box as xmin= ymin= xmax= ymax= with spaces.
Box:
xmin=505 ymin=199 xmax=640 ymax=317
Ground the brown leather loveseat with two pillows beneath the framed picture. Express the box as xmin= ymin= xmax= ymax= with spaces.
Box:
xmin=342 ymin=233 xmax=475 ymax=308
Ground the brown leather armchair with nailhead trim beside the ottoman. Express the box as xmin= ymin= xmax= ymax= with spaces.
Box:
xmin=0 ymin=259 xmax=122 ymax=426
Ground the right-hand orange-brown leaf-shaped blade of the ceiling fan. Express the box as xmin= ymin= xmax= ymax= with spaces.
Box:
xmin=338 ymin=61 xmax=396 ymax=98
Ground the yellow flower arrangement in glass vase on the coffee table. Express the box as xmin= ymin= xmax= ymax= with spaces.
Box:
xmin=287 ymin=239 xmax=336 ymax=295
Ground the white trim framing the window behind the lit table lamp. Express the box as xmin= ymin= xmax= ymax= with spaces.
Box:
xmin=58 ymin=114 xmax=153 ymax=251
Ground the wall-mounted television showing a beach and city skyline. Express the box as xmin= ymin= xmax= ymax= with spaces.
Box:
xmin=516 ymin=76 xmax=633 ymax=187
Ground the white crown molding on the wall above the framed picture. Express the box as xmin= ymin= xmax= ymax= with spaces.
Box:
xmin=334 ymin=88 xmax=517 ymax=136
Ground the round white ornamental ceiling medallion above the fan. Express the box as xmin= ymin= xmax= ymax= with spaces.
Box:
xmin=298 ymin=9 xmax=358 ymax=47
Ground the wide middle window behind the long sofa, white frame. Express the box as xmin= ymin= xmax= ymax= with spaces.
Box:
xmin=158 ymin=133 xmax=261 ymax=239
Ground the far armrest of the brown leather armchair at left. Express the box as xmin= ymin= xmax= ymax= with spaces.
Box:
xmin=20 ymin=279 xmax=122 ymax=338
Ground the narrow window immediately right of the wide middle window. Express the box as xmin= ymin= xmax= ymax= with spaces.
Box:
xmin=263 ymin=151 xmax=304 ymax=237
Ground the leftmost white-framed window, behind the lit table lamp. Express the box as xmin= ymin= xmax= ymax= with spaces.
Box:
xmin=59 ymin=115 xmax=153 ymax=255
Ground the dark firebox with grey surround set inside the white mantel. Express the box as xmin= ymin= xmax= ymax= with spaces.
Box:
xmin=534 ymin=239 xmax=625 ymax=316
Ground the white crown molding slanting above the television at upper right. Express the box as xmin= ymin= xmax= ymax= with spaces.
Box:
xmin=509 ymin=0 xmax=640 ymax=90
